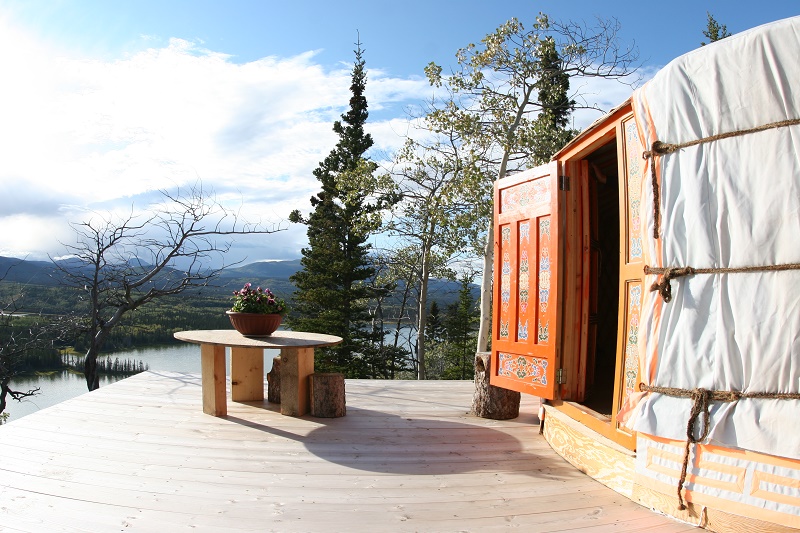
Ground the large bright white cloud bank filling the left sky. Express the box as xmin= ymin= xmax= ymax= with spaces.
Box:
xmin=0 ymin=20 xmax=426 ymax=260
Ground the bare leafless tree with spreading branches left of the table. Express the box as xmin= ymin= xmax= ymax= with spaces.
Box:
xmin=54 ymin=184 xmax=283 ymax=391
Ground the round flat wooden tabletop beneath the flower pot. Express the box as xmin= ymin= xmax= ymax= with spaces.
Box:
xmin=175 ymin=329 xmax=342 ymax=348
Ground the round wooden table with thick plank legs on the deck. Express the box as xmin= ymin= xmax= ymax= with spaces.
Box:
xmin=175 ymin=329 xmax=342 ymax=416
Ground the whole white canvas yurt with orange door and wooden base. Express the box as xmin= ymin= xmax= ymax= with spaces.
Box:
xmin=490 ymin=17 xmax=800 ymax=532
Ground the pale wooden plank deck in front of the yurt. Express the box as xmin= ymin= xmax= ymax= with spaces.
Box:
xmin=0 ymin=372 xmax=695 ymax=533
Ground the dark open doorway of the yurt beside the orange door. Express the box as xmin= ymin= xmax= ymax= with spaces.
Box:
xmin=582 ymin=140 xmax=620 ymax=416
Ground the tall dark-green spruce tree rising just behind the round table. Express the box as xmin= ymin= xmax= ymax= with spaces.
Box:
xmin=288 ymin=42 xmax=396 ymax=377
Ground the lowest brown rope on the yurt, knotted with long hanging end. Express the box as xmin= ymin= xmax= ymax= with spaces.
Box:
xmin=639 ymin=383 xmax=800 ymax=511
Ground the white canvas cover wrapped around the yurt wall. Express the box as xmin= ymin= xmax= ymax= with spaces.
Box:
xmin=623 ymin=17 xmax=800 ymax=459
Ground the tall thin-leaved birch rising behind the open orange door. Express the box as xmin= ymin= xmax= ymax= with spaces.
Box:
xmin=425 ymin=13 xmax=637 ymax=351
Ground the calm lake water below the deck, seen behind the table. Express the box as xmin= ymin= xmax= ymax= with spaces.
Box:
xmin=5 ymin=344 xmax=280 ymax=422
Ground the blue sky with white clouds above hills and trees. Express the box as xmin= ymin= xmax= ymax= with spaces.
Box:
xmin=0 ymin=0 xmax=800 ymax=263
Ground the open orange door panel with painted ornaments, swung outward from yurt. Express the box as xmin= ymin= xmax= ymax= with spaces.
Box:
xmin=490 ymin=163 xmax=559 ymax=399
